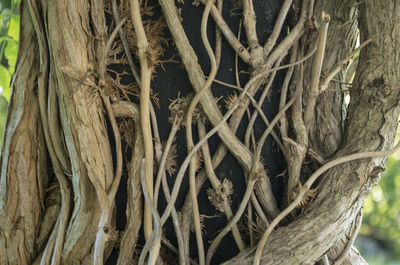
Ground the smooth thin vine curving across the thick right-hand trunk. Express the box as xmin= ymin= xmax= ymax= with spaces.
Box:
xmin=253 ymin=142 xmax=400 ymax=265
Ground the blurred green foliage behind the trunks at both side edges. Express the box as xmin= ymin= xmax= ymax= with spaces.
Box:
xmin=0 ymin=0 xmax=400 ymax=265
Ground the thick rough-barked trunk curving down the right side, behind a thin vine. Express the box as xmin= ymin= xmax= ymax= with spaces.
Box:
xmin=226 ymin=0 xmax=400 ymax=264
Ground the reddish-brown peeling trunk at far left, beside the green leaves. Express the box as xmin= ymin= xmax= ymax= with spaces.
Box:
xmin=0 ymin=2 xmax=47 ymax=264
